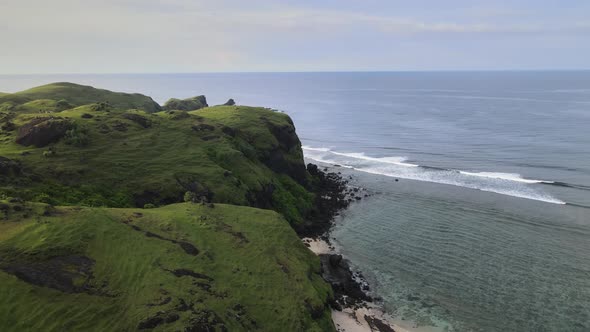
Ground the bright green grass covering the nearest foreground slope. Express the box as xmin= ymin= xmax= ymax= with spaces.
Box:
xmin=0 ymin=203 xmax=333 ymax=331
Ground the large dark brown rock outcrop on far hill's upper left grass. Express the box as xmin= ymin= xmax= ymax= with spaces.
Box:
xmin=16 ymin=118 xmax=71 ymax=148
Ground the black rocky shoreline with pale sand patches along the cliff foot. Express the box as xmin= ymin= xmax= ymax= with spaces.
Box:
xmin=298 ymin=164 xmax=404 ymax=332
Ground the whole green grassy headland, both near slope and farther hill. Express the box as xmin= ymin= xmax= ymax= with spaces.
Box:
xmin=0 ymin=83 xmax=334 ymax=331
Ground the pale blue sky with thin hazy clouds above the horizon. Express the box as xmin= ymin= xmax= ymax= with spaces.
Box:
xmin=0 ymin=0 xmax=590 ymax=74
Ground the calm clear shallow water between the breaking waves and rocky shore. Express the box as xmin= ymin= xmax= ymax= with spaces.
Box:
xmin=332 ymin=170 xmax=590 ymax=331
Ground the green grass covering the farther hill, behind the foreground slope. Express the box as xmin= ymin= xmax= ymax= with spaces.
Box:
xmin=0 ymin=85 xmax=312 ymax=223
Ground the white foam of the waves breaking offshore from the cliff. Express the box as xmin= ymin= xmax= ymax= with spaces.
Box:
xmin=303 ymin=146 xmax=565 ymax=204
